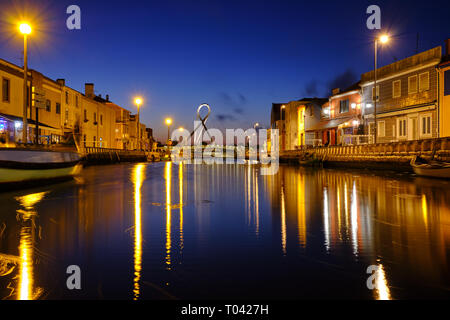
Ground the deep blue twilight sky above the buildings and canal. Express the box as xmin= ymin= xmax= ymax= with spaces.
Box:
xmin=0 ymin=0 xmax=450 ymax=140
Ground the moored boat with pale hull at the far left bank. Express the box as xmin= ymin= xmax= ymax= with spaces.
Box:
xmin=0 ymin=148 xmax=81 ymax=187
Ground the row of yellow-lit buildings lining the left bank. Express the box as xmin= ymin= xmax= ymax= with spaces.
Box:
xmin=0 ymin=59 xmax=153 ymax=150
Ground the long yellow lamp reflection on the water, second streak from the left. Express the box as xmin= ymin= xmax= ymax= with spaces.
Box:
xmin=132 ymin=164 xmax=145 ymax=300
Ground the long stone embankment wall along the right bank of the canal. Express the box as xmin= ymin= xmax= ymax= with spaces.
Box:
xmin=280 ymin=138 xmax=450 ymax=171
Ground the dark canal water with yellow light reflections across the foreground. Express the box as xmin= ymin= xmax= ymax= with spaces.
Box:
xmin=0 ymin=163 xmax=450 ymax=299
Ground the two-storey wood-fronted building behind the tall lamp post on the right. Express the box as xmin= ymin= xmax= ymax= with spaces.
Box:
xmin=361 ymin=47 xmax=442 ymax=143
